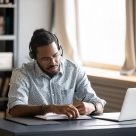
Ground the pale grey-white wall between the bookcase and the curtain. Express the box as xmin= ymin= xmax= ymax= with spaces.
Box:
xmin=17 ymin=0 xmax=51 ymax=66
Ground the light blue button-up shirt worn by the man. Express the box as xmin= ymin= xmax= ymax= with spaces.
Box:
xmin=8 ymin=58 xmax=106 ymax=109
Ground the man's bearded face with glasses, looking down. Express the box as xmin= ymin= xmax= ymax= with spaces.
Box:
xmin=36 ymin=42 xmax=60 ymax=74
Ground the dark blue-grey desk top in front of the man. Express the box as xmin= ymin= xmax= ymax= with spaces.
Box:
xmin=0 ymin=119 xmax=136 ymax=136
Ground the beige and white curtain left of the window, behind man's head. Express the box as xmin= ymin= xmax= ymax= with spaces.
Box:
xmin=53 ymin=0 xmax=80 ymax=63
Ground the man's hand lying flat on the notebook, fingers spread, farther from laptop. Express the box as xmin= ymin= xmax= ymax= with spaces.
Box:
xmin=47 ymin=104 xmax=80 ymax=119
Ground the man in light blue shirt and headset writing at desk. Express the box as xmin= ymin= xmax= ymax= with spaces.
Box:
xmin=8 ymin=29 xmax=106 ymax=119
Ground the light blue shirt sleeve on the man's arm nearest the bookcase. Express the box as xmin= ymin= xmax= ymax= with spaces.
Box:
xmin=8 ymin=69 xmax=29 ymax=110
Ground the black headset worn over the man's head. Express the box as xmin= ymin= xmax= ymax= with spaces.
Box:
xmin=29 ymin=30 xmax=63 ymax=59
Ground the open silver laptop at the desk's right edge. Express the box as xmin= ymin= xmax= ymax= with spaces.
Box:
xmin=93 ymin=88 xmax=136 ymax=122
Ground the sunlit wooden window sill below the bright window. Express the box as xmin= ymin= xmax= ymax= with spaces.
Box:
xmin=84 ymin=67 xmax=136 ymax=88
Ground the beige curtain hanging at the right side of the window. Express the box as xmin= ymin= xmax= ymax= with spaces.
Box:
xmin=121 ymin=0 xmax=136 ymax=75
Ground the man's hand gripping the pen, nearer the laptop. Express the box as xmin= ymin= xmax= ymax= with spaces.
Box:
xmin=73 ymin=101 xmax=95 ymax=115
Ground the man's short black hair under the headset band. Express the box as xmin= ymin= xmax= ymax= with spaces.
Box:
xmin=29 ymin=28 xmax=58 ymax=58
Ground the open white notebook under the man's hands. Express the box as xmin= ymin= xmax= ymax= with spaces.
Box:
xmin=35 ymin=113 xmax=92 ymax=120
